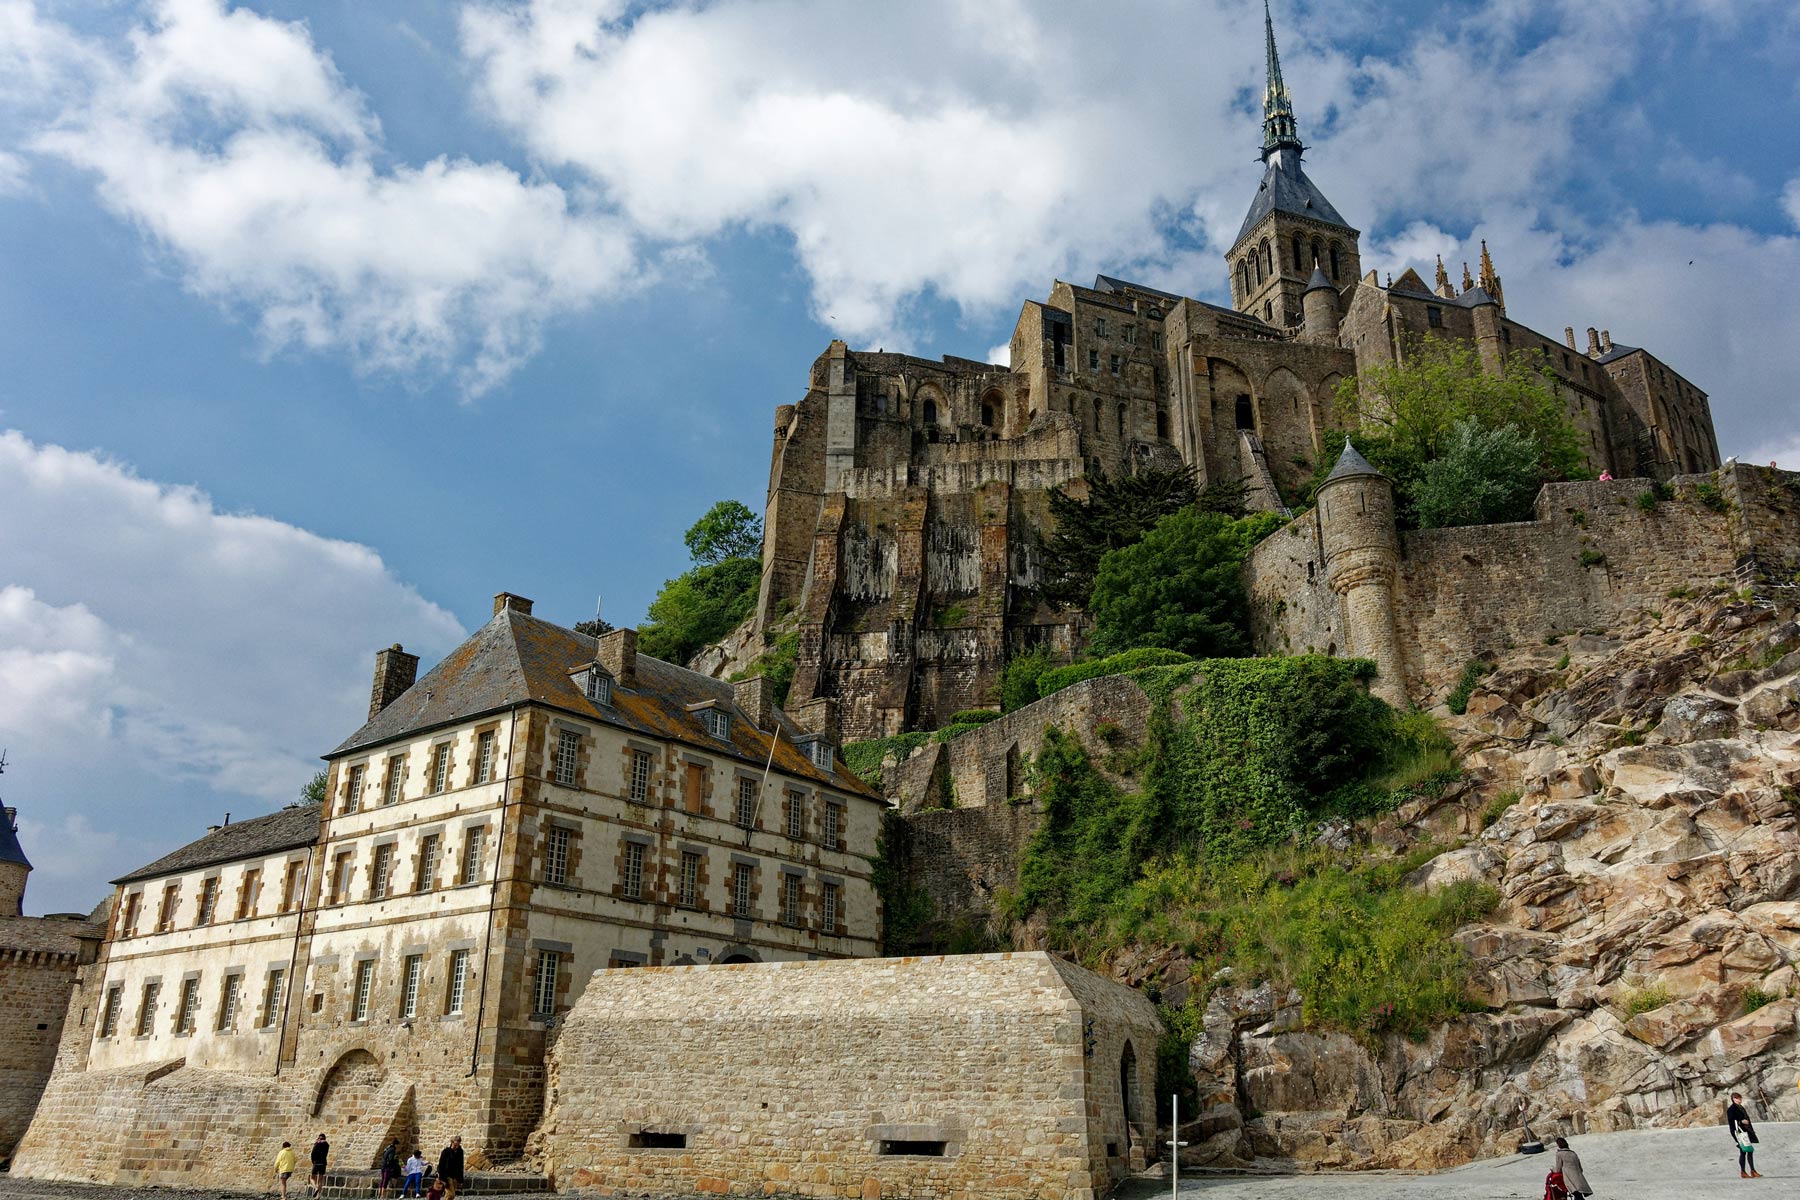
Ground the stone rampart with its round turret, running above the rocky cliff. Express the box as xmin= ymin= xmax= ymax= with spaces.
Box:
xmin=1244 ymin=455 xmax=1800 ymax=702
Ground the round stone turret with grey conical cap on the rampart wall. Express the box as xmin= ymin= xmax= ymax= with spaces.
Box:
xmin=1318 ymin=439 xmax=1408 ymax=707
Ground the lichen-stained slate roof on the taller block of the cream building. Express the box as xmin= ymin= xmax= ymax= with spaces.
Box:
xmin=326 ymin=608 xmax=878 ymax=799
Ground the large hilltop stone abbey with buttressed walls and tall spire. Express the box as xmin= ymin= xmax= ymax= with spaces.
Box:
xmin=756 ymin=4 xmax=1719 ymax=739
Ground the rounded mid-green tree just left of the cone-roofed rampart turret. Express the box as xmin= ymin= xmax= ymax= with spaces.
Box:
xmin=1087 ymin=507 xmax=1280 ymax=658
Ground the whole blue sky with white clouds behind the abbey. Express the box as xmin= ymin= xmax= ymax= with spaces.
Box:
xmin=0 ymin=0 xmax=1800 ymax=912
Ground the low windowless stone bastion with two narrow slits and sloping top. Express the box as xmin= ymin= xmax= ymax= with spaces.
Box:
xmin=533 ymin=954 xmax=1161 ymax=1200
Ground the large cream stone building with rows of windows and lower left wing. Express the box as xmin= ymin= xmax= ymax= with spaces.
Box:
xmin=14 ymin=594 xmax=886 ymax=1186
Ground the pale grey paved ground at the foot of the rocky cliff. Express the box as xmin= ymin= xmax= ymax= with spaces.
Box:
xmin=1120 ymin=1123 xmax=1800 ymax=1200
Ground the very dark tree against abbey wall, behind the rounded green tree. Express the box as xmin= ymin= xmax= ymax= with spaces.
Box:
xmin=1044 ymin=466 xmax=1199 ymax=604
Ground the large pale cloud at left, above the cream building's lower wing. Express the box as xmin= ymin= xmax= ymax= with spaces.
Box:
xmin=0 ymin=432 xmax=461 ymax=907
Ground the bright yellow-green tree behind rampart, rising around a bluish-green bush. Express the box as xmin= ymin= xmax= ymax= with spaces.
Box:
xmin=1309 ymin=338 xmax=1591 ymax=525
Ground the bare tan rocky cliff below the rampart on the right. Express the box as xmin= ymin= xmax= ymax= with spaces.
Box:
xmin=1152 ymin=588 xmax=1800 ymax=1168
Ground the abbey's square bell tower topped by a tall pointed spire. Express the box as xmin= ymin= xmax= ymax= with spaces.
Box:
xmin=1226 ymin=0 xmax=1363 ymax=327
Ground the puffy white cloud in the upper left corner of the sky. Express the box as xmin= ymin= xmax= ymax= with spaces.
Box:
xmin=19 ymin=0 xmax=641 ymax=394
